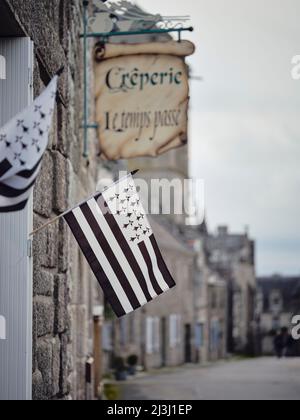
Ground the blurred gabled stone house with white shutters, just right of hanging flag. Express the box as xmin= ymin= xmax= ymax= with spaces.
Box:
xmin=144 ymin=218 xmax=196 ymax=368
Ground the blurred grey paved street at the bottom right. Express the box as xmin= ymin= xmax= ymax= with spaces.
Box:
xmin=122 ymin=358 xmax=300 ymax=400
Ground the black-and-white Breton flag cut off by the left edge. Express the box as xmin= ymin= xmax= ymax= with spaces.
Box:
xmin=0 ymin=76 xmax=58 ymax=213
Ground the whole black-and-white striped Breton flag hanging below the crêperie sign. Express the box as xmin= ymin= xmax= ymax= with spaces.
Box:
xmin=64 ymin=175 xmax=175 ymax=317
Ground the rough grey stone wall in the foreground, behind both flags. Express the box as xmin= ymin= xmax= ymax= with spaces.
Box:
xmin=5 ymin=0 xmax=100 ymax=399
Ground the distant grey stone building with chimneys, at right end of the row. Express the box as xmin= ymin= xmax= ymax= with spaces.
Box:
xmin=205 ymin=227 xmax=256 ymax=354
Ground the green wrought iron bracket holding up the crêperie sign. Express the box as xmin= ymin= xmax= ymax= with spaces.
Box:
xmin=80 ymin=0 xmax=194 ymax=158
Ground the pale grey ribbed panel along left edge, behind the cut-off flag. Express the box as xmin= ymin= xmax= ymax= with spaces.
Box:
xmin=0 ymin=38 xmax=33 ymax=400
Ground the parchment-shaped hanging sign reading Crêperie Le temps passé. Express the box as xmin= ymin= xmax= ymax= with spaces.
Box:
xmin=95 ymin=41 xmax=195 ymax=160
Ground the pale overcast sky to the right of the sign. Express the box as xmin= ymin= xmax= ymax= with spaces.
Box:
xmin=138 ymin=0 xmax=300 ymax=275
